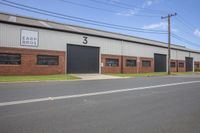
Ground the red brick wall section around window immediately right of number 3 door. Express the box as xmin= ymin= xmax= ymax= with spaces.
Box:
xmin=101 ymin=54 xmax=122 ymax=73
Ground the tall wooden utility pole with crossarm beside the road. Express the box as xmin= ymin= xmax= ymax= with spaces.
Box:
xmin=161 ymin=13 xmax=177 ymax=75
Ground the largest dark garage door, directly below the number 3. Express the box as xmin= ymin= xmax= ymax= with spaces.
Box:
xmin=67 ymin=44 xmax=99 ymax=73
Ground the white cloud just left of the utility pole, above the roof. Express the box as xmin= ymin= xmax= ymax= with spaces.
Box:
xmin=143 ymin=22 xmax=167 ymax=30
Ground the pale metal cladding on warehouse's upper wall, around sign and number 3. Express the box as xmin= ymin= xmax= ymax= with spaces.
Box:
xmin=0 ymin=23 xmax=200 ymax=61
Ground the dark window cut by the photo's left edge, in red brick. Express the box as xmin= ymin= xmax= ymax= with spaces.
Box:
xmin=0 ymin=53 xmax=21 ymax=65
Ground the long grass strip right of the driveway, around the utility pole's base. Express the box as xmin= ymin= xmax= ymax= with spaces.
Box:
xmin=109 ymin=72 xmax=200 ymax=77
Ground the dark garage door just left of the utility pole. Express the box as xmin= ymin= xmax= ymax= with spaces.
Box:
xmin=154 ymin=54 xmax=166 ymax=72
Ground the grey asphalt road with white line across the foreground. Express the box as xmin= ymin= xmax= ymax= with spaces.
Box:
xmin=0 ymin=75 xmax=200 ymax=133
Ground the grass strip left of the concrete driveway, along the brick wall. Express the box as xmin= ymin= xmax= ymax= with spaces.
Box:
xmin=0 ymin=74 xmax=79 ymax=82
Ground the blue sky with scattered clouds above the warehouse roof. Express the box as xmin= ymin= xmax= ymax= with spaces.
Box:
xmin=0 ymin=0 xmax=200 ymax=50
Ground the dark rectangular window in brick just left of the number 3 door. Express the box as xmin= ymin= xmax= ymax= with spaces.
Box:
xmin=37 ymin=55 xmax=59 ymax=65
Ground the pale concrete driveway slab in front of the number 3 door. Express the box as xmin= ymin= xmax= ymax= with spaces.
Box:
xmin=72 ymin=74 xmax=122 ymax=80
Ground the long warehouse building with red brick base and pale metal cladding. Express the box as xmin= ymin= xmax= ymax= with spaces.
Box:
xmin=0 ymin=13 xmax=200 ymax=75
